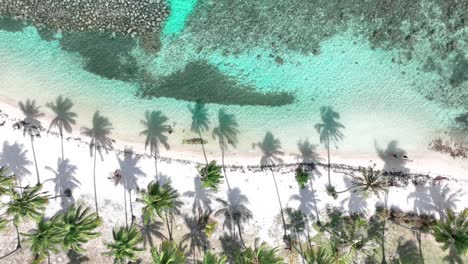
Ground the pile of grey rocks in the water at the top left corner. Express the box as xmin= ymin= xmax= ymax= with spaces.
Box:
xmin=0 ymin=0 xmax=169 ymax=36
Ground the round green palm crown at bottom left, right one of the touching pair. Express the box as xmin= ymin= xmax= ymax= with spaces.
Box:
xmin=56 ymin=205 xmax=101 ymax=253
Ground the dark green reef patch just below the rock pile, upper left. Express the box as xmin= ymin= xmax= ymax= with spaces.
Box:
xmin=60 ymin=32 xmax=139 ymax=81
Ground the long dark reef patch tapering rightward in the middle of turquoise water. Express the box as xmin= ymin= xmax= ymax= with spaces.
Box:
xmin=138 ymin=61 xmax=294 ymax=106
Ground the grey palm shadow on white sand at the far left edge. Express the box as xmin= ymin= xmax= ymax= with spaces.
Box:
xmin=0 ymin=141 xmax=32 ymax=187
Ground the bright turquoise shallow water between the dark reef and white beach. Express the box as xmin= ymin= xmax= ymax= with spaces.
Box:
xmin=0 ymin=0 xmax=463 ymax=159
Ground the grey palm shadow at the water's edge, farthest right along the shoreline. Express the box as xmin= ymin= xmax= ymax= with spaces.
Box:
xmin=374 ymin=140 xmax=409 ymax=173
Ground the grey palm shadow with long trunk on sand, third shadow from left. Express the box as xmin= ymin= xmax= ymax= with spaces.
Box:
xmin=115 ymin=150 xmax=145 ymax=225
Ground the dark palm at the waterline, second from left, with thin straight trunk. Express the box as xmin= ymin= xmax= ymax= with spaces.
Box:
xmin=46 ymin=95 xmax=77 ymax=160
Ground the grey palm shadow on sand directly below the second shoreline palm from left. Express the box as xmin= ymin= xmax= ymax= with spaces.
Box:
xmin=45 ymin=158 xmax=80 ymax=209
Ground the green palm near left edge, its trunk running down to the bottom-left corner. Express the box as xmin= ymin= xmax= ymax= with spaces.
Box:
xmin=6 ymin=185 xmax=49 ymax=248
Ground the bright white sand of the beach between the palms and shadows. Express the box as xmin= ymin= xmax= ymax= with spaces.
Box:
xmin=0 ymin=98 xmax=468 ymax=262
